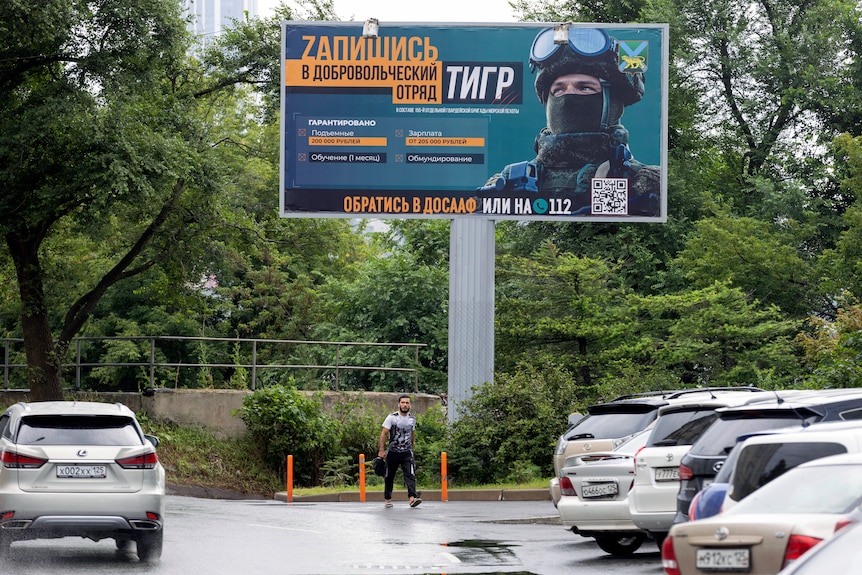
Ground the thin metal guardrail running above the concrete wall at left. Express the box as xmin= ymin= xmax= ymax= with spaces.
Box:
xmin=0 ymin=336 xmax=427 ymax=393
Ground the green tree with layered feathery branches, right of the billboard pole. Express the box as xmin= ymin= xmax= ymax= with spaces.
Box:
xmin=497 ymin=245 xmax=803 ymax=397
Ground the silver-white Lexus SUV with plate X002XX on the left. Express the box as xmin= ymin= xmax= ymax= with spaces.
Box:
xmin=0 ymin=401 xmax=165 ymax=562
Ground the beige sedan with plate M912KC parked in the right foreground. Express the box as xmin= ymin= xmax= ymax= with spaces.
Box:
xmin=662 ymin=453 xmax=862 ymax=575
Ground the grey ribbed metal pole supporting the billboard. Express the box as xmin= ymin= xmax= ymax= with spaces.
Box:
xmin=448 ymin=218 xmax=495 ymax=422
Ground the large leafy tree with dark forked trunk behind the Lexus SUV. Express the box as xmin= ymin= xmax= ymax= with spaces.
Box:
xmin=0 ymin=0 xmax=318 ymax=400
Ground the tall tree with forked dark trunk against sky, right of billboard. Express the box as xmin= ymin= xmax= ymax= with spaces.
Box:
xmin=645 ymin=0 xmax=859 ymax=209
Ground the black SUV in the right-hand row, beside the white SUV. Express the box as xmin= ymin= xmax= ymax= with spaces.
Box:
xmin=674 ymin=388 xmax=862 ymax=523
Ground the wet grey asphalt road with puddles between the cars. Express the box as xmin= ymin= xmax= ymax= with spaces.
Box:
xmin=0 ymin=496 xmax=663 ymax=575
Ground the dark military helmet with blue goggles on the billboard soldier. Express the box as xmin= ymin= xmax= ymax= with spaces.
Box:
xmin=530 ymin=27 xmax=644 ymax=106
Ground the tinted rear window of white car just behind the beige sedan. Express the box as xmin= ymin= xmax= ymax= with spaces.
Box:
xmin=730 ymin=441 xmax=847 ymax=501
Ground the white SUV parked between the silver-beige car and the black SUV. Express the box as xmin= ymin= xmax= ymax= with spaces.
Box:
xmin=628 ymin=390 xmax=774 ymax=546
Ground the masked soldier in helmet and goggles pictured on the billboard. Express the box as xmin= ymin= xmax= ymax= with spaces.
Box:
xmin=478 ymin=27 xmax=661 ymax=216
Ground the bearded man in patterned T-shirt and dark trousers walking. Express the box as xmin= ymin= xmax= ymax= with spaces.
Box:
xmin=377 ymin=395 xmax=422 ymax=507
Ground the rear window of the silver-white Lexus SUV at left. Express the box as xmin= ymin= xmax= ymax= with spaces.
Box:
xmin=15 ymin=415 xmax=143 ymax=445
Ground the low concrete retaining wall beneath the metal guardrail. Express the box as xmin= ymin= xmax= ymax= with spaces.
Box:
xmin=0 ymin=389 xmax=441 ymax=437
